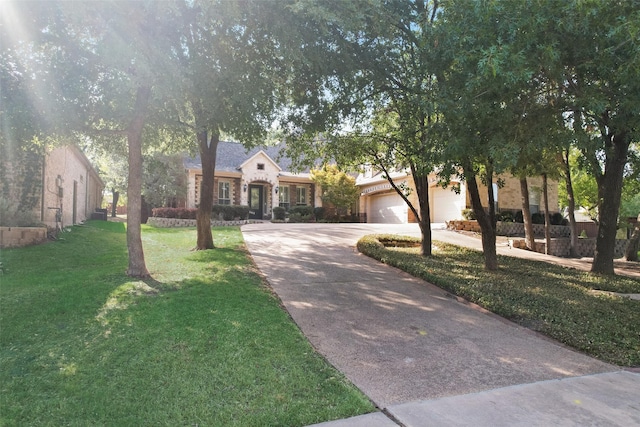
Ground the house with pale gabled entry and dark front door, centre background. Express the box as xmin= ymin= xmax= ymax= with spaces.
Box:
xmin=185 ymin=141 xmax=322 ymax=219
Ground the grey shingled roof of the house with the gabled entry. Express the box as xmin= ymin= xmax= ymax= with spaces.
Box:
xmin=184 ymin=141 xmax=304 ymax=172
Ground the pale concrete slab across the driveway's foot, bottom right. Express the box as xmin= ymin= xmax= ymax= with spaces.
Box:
xmin=315 ymin=372 xmax=640 ymax=427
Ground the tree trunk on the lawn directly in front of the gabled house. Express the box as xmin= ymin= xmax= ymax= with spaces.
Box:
xmin=195 ymin=130 xmax=220 ymax=251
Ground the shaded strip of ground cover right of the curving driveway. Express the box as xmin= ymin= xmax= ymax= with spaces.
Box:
xmin=358 ymin=235 xmax=640 ymax=367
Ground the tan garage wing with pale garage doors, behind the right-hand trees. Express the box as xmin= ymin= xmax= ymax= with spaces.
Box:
xmin=356 ymin=169 xmax=558 ymax=224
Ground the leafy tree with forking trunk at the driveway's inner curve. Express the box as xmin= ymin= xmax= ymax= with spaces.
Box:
xmin=288 ymin=0 xmax=438 ymax=255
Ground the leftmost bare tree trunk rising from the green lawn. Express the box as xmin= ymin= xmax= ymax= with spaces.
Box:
xmin=127 ymin=86 xmax=151 ymax=277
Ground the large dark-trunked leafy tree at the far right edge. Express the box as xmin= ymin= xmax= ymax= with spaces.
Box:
xmin=547 ymin=1 xmax=640 ymax=274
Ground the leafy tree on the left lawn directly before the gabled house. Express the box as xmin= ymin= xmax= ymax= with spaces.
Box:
xmin=174 ymin=0 xmax=342 ymax=250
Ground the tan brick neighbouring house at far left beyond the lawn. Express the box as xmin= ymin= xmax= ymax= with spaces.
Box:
xmin=36 ymin=144 xmax=104 ymax=231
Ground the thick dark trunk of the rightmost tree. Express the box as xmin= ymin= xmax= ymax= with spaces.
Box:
xmin=591 ymin=133 xmax=630 ymax=275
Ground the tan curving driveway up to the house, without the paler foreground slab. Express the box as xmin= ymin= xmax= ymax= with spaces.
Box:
xmin=242 ymin=223 xmax=618 ymax=408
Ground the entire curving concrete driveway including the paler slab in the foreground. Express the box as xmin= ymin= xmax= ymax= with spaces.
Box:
xmin=242 ymin=223 xmax=640 ymax=427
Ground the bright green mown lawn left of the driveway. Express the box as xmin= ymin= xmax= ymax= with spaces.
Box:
xmin=0 ymin=221 xmax=374 ymax=426
